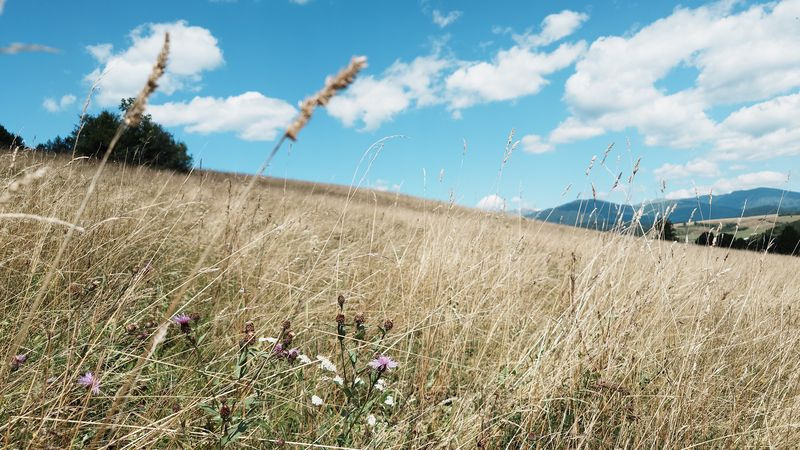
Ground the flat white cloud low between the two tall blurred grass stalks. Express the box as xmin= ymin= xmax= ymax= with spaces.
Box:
xmin=148 ymin=92 xmax=297 ymax=141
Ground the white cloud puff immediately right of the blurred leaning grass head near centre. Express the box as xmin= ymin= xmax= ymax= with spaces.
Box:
xmin=326 ymin=55 xmax=451 ymax=130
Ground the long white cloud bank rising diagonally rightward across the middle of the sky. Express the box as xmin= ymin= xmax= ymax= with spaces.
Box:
xmin=328 ymin=11 xmax=587 ymax=130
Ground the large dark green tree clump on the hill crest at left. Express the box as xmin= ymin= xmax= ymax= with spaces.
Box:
xmin=36 ymin=99 xmax=192 ymax=172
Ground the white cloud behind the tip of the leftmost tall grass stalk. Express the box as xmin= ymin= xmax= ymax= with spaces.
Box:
xmin=85 ymin=21 xmax=223 ymax=106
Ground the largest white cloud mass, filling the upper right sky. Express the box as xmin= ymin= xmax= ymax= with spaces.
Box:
xmin=550 ymin=0 xmax=800 ymax=158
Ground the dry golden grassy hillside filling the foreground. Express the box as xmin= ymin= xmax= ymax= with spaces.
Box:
xmin=0 ymin=151 xmax=800 ymax=449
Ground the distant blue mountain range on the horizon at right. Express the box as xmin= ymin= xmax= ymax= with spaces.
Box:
xmin=524 ymin=188 xmax=800 ymax=230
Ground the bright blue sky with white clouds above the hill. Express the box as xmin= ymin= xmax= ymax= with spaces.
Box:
xmin=0 ymin=0 xmax=800 ymax=209
